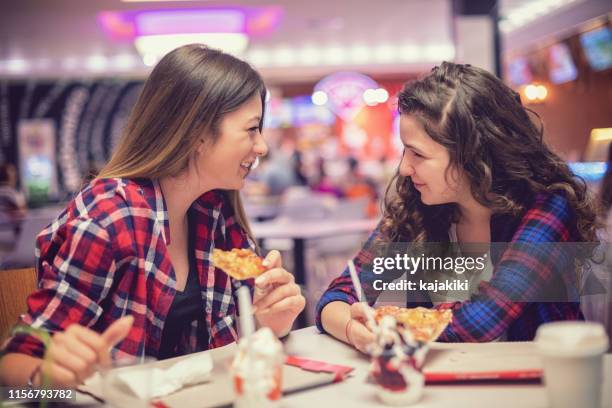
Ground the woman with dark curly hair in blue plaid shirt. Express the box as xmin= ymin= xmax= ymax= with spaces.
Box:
xmin=317 ymin=62 xmax=597 ymax=350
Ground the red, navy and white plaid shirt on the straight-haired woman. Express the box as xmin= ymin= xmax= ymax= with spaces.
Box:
xmin=5 ymin=179 xmax=253 ymax=357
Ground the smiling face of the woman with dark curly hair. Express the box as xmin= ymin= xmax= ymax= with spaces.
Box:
xmin=399 ymin=114 xmax=466 ymax=205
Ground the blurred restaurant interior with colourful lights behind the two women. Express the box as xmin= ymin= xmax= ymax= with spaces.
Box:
xmin=0 ymin=0 xmax=612 ymax=326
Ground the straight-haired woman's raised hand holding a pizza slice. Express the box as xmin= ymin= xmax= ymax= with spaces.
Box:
xmin=253 ymin=250 xmax=306 ymax=337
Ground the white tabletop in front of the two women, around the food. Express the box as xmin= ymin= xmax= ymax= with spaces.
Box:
xmin=71 ymin=327 xmax=612 ymax=408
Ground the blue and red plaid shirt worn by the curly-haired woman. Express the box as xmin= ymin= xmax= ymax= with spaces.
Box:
xmin=316 ymin=194 xmax=583 ymax=342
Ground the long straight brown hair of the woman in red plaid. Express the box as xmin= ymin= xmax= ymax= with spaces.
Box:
xmin=97 ymin=44 xmax=266 ymax=240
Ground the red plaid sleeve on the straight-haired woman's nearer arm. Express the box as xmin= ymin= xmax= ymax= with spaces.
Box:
xmin=4 ymin=218 xmax=115 ymax=358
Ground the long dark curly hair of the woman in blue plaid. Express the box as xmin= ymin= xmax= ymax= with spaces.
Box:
xmin=381 ymin=62 xmax=599 ymax=242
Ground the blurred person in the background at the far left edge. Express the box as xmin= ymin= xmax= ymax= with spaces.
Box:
xmin=0 ymin=163 xmax=27 ymax=234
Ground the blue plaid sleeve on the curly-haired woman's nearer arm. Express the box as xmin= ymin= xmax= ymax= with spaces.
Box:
xmin=436 ymin=195 xmax=574 ymax=342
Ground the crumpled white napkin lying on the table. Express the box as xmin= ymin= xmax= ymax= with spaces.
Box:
xmin=116 ymin=353 xmax=213 ymax=399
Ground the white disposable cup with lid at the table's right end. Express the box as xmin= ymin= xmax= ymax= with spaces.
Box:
xmin=535 ymin=322 xmax=609 ymax=408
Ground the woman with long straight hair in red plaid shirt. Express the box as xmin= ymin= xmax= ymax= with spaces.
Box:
xmin=0 ymin=44 xmax=305 ymax=388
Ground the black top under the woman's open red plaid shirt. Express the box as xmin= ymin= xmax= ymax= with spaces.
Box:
xmin=157 ymin=215 xmax=204 ymax=360
